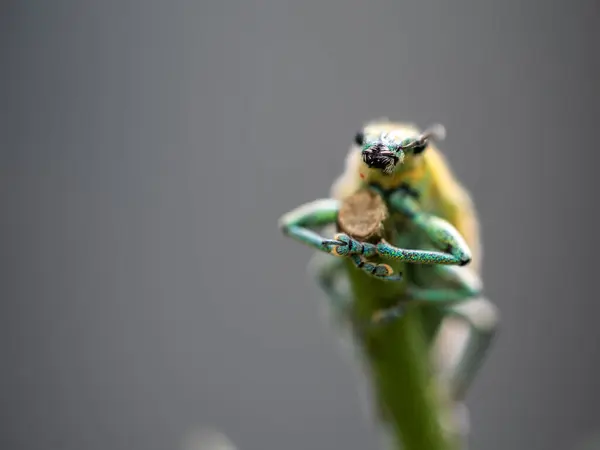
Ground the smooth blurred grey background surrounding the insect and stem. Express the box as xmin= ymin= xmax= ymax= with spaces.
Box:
xmin=0 ymin=0 xmax=600 ymax=450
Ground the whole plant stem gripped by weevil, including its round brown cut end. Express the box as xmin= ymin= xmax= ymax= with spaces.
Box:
xmin=338 ymin=191 xmax=458 ymax=450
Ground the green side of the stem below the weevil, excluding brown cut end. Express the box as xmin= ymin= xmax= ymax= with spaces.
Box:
xmin=346 ymin=270 xmax=458 ymax=450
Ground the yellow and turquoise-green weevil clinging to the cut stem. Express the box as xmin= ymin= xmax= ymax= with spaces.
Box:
xmin=279 ymin=119 xmax=498 ymax=446
